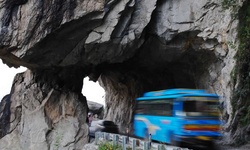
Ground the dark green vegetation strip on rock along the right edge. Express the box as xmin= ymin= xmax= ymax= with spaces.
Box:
xmin=222 ymin=0 xmax=250 ymax=145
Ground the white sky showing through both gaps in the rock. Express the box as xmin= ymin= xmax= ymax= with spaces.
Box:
xmin=0 ymin=59 xmax=105 ymax=106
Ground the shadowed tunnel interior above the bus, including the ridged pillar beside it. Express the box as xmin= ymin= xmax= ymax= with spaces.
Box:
xmin=98 ymin=31 xmax=223 ymax=132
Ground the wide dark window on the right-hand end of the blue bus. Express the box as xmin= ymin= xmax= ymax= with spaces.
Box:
xmin=183 ymin=99 xmax=219 ymax=117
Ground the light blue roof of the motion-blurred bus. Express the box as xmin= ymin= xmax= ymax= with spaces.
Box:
xmin=136 ymin=89 xmax=219 ymax=100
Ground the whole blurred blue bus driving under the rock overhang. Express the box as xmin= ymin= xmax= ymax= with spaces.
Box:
xmin=133 ymin=89 xmax=221 ymax=146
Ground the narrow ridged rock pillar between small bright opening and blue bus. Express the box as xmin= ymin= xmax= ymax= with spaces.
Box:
xmin=99 ymin=71 xmax=143 ymax=133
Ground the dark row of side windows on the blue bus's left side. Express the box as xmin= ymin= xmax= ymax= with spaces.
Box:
xmin=135 ymin=100 xmax=173 ymax=116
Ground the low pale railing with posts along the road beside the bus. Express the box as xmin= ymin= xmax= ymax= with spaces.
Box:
xmin=95 ymin=132 xmax=190 ymax=150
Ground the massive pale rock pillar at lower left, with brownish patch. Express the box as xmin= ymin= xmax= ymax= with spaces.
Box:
xmin=0 ymin=70 xmax=88 ymax=150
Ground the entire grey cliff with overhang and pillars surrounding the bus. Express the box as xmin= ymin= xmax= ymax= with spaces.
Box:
xmin=0 ymin=0 xmax=249 ymax=149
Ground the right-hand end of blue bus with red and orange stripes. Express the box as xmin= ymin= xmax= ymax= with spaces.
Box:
xmin=174 ymin=94 xmax=221 ymax=148
